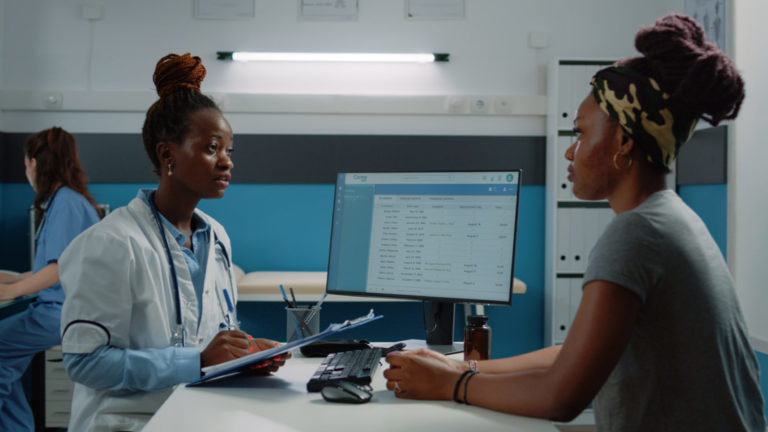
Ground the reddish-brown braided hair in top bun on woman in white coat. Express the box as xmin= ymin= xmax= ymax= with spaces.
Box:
xmin=141 ymin=53 xmax=221 ymax=175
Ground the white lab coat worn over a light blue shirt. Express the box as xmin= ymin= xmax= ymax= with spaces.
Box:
xmin=59 ymin=198 xmax=237 ymax=431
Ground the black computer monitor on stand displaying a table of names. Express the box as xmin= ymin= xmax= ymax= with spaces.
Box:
xmin=326 ymin=169 xmax=521 ymax=345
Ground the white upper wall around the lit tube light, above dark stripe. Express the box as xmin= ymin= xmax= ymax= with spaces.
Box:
xmin=0 ymin=0 xmax=682 ymax=135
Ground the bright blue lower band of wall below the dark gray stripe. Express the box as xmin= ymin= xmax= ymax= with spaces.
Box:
xmin=0 ymin=183 xmax=768 ymax=415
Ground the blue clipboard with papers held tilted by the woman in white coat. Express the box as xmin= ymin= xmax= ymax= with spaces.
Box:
xmin=187 ymin=309 xmax=383 ymax=387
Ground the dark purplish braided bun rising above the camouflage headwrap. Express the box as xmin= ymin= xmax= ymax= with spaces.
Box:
xmin=621 ymin=14 xmax=744 ymax=126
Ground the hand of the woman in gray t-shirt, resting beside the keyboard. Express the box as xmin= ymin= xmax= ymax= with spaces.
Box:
xmin=384 ymin=350 xmax=462 ymax=400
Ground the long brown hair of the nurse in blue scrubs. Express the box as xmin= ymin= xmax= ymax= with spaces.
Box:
xmin=23 ymin=127 xmax=101 ymax=226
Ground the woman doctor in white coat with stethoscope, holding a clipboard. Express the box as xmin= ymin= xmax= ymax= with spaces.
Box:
xmin=59 ymin=54 xmax=284 ymax=431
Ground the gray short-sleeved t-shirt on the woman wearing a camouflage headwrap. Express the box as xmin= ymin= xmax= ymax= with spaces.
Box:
xmin=584 ymin=190 xmax=765 ymax=432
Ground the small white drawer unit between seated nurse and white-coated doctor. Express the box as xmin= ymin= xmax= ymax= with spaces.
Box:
xmin=45 ymin=347 xmax=75 ymax=428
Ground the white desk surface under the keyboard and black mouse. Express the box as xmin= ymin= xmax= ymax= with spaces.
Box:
xmin=144 ymin=357 xmax=557 ymax=432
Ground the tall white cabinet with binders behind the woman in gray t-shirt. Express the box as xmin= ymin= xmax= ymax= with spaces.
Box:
xmin=544 ymin=59 xmax=675 ymax=346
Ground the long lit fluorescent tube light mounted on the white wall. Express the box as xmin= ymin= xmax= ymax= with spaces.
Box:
xmin=216 ymin=51 xmax=450 ymax=63
